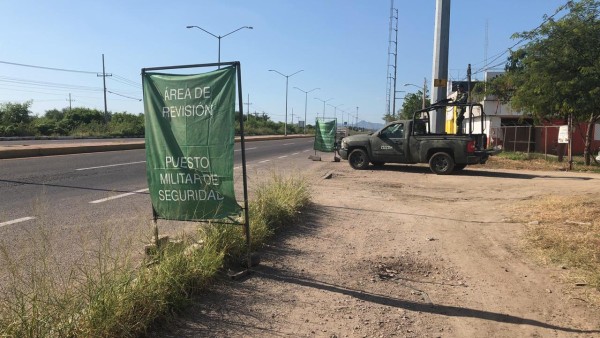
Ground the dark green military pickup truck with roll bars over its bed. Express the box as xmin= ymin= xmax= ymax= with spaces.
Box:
xmin=338 ymin=102 xmax=498 ymax=175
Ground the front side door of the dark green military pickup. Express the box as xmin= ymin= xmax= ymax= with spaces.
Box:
xmin=371 ymin=122 xmax=407 ymax=163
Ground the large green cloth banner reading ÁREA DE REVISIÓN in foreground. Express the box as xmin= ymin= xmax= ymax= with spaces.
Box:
xmin=143 ymin=67 xmax=241 ymax=221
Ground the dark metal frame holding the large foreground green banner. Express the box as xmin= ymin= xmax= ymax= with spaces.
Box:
xmin=142 ymin=61 xmax=252 ymax=269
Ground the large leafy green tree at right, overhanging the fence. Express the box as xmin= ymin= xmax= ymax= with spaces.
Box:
xmin=491 ymin=0 xmax=600 ymax=165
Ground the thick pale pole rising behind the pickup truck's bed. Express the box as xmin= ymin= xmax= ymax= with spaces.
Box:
xmin=431 ymin=0 xmax=450 ymax=133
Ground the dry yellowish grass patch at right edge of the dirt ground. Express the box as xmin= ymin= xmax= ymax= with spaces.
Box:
xmin=515 ymin=194 xmax=600 ymax=290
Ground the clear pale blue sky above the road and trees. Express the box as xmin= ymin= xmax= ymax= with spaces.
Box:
xmin=0 ymin=0 xmax=566 ymax=124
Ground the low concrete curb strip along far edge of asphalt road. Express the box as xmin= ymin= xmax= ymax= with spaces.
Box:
xmin=0 ymin=135 xmax=314 ymax=159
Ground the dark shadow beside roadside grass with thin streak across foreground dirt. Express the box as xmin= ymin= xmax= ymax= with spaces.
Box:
xmin=148 ymin=205 xmax=600 ymax=337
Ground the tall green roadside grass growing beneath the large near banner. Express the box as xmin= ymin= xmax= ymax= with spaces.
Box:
xmin=0 ymin=175 xmax=310 ymax=338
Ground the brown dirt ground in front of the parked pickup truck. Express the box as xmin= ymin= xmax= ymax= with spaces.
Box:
xmin=150 ymin=161 xmax=600 ymax=338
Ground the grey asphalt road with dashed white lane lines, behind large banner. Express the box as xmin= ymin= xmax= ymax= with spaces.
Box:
xmin=0 ymin=138 xmax=314 ymax=270
